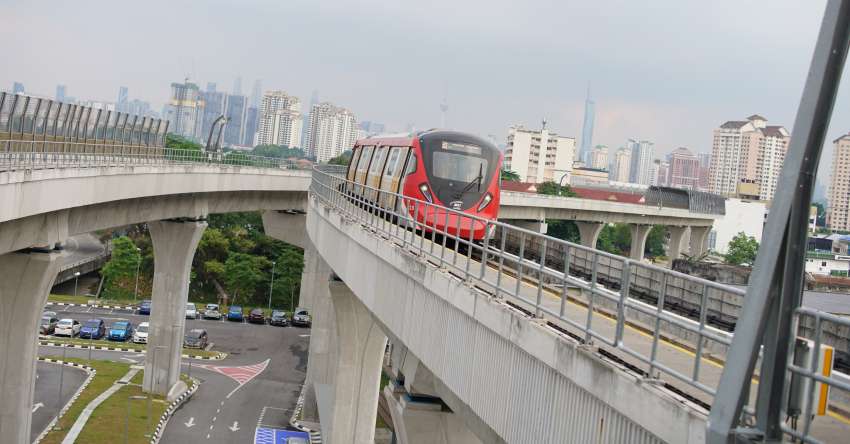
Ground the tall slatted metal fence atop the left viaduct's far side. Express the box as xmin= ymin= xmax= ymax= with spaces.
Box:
xmin=0 ymin=92 xmax=168 ymax=147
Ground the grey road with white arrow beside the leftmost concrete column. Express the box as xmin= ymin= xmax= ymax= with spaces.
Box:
xmin=30 ymin=362 xmax=88 ymax=441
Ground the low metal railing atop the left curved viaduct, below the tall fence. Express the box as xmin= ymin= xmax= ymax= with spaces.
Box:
xmin=0 ymin=140 xmax=299 ymax=171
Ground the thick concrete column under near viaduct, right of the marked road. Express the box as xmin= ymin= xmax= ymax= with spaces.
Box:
xmin=319 ymin=281 xmax=387 ymax=444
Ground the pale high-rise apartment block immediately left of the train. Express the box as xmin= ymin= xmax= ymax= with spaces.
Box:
xmin=306 ymin=102 xmax=357 ymax=163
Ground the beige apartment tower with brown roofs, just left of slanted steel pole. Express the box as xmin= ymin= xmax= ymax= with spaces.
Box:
xmin=709 ymin=115 xmax=791 ymax=200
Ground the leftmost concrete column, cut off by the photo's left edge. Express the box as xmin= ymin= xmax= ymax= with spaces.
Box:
xmin=0 ymin=252 xmax=61 ymax=444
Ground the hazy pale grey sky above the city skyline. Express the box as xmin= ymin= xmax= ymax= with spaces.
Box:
xmin=0 ymin=0 xmax=850 ymax=189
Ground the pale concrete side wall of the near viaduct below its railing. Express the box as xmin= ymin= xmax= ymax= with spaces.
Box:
xmin=307 ymin=196 xmax=705 ymax=443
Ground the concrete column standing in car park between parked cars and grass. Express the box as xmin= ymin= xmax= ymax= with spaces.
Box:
xmin=142 ymin=220 xmax=207 ymax=395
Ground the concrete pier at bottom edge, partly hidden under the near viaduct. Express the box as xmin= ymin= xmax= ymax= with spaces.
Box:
xmin=382 ymin=382 xmax=481 ymax=444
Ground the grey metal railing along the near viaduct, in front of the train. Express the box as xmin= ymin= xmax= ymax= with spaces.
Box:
xmin=310 ymin=166 xmax=744 ymax=408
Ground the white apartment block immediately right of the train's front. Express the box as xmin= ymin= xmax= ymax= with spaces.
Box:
xmin=505 ymin=123 xmax=576 ymax=183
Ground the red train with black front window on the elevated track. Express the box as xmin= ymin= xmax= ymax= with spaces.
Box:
xmin=347 ymin=130 xmax=502 ymax=240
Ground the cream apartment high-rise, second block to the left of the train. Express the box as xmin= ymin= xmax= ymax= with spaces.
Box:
xmin=257 ymin=91 xmax=302 ymax=148
